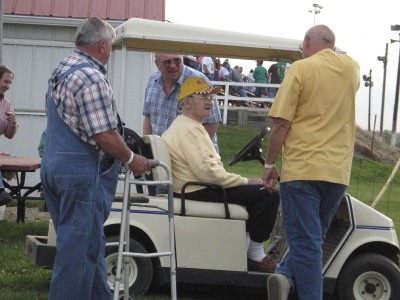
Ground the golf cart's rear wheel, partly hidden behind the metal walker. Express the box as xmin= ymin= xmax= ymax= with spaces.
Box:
xmin=105 ymin=236 xmax=153 ymax=297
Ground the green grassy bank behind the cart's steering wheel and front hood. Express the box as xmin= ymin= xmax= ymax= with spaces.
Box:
xmin=218 ymin=126 xmax=400 ymax=230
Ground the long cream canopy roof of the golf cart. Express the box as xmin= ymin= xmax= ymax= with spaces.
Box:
xmin=114 ymin=18 xmax=302 ymax=62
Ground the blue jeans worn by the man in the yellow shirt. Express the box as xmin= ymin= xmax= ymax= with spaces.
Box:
xmin=276 ymin=180 xmax=347 ymax=300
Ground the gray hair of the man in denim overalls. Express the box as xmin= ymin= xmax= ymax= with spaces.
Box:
xmin=75 ymin=17 xmax=115 ymax=47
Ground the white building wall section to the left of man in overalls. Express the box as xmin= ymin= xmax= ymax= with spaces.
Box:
xmin=0 ymin=24 xmax=76 ymax=157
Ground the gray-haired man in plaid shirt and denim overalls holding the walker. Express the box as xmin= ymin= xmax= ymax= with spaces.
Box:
xmin=40 ymin=17 xmax=151 ymax=300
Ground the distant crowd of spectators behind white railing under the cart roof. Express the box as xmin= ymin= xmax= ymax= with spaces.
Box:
xmin=184 ymin=55 xmax=290 ymax=107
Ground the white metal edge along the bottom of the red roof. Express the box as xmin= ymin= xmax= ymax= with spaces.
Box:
xmin=3 ymin=14 xmax=124 ymax=27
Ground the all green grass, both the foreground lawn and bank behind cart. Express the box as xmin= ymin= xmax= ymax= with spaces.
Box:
xmin=0 ymin=126 xmax=400 ymax=300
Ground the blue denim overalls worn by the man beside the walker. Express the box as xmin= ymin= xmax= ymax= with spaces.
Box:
xmin=40 ymin=64 xmax=121 ymax=300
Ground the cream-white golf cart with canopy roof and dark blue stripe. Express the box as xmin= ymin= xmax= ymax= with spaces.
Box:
xmin=26 ymin=20 xmax=400 ymax=300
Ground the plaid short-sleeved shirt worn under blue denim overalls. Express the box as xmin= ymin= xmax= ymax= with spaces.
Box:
xmin=49 ymin=49 xmax=118 ymax=145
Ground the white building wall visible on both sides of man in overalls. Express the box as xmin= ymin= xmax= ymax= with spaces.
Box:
xmin=0 ymin=24 xmax=155 ymax=192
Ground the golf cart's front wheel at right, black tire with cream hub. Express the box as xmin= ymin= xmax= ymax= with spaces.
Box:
xmin=337 ymin=253 xmax=400 ymax=300
